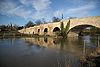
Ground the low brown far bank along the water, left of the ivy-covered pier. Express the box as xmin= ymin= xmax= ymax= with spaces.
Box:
xmin=0 ymin=31 xmax=53 ymax=38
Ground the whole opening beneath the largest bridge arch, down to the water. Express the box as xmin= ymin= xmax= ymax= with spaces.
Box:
xmin=69 ymin=25 xmax=100 ymax=36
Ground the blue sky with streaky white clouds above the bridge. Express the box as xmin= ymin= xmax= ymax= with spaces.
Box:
xmin=0 ymin=0 xmax=100 ymax=25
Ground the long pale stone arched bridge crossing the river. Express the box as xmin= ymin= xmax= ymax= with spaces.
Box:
xmin=19 ymin=16 xmax=100 ymax=35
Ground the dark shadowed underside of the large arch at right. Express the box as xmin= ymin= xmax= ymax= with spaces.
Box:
xmin=67 ymin=24 xmax=100 ymax=35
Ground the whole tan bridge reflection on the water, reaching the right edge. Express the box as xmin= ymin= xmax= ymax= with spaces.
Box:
xmin=22 ymin=36 xmax=100 ymax=60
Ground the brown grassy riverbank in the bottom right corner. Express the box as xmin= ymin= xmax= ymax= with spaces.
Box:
xmin=80 ymin=47 xmax=100 ymax=67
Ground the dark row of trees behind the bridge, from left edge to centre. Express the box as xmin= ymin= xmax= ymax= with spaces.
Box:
xmin=0 ymin=17 xmax=61 ymax=31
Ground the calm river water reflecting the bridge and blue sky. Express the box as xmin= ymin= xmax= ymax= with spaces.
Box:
xmin=0 ymin=36 xmax=100 ymax=67
